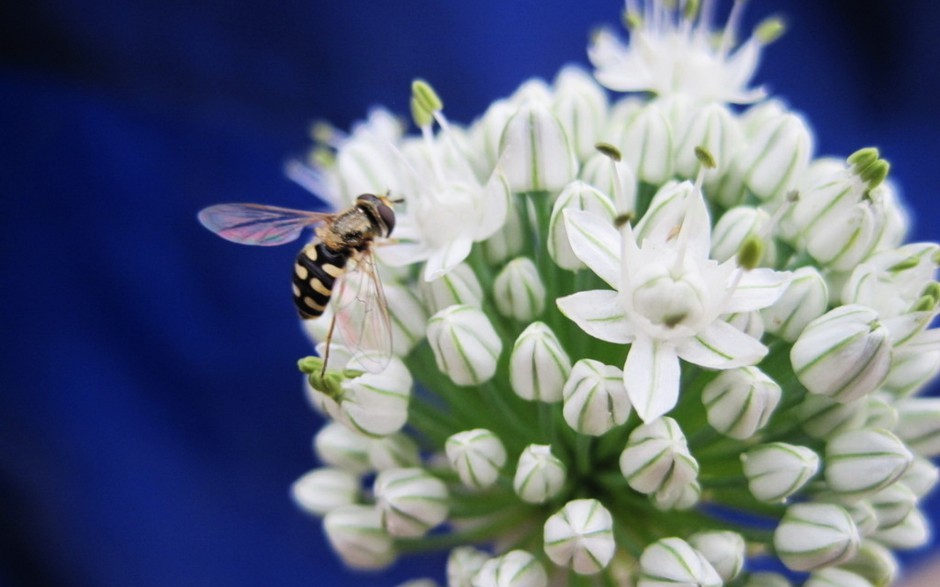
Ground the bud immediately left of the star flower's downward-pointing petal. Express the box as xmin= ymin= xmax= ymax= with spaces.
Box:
xmin=562 ymin=359 xmax=636 ymax=436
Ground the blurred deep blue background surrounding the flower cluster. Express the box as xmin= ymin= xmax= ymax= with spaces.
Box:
xmin=0 ymin=0 xmax=940 ymax=587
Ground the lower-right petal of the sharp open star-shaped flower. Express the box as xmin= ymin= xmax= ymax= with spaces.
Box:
xmin=676 ymin=320 xmax=767 ymax=369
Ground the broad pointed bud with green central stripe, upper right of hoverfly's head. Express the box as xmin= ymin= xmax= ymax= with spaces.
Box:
xmin=499 ymin=102 xmax=577 ymax=192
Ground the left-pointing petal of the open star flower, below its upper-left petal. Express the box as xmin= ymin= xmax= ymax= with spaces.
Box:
xmin=555 ymin=289 xmax=634 ymax=344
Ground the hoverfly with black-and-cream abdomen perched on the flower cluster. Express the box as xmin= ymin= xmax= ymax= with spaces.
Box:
xmin=199 ymin=194 xmax=400 ymax=376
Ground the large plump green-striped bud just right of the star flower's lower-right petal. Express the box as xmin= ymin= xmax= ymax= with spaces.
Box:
xmin=790 ymin=305 xmax=891 ymax=402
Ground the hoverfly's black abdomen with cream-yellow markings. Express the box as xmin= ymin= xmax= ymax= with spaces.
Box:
xmin=293 ymin=241 xmax=349 ymax=319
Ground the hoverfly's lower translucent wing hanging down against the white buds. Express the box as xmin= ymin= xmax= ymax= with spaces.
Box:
xmin=333 ymin=250 xmax=392 ymax=373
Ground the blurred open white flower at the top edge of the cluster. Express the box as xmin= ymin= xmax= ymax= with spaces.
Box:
xmin=588 ymin=0 xmax=769 ymax=104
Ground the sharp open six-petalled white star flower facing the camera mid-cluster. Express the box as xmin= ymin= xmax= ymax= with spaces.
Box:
xmin=557 ymin=184 xmax=788 ymax=422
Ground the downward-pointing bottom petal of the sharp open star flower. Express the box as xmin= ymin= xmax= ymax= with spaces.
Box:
xmin=623 ymin=336 xmax=679 ymax=422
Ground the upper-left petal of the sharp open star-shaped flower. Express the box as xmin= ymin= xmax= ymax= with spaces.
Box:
xmin=563 ymin=209 xmax=620 ymax=287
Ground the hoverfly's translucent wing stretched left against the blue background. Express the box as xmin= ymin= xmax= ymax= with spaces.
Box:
xmin=199 ymin=204 xmax=333 ymax=246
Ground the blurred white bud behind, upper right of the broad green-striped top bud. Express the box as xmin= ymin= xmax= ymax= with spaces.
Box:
xmin=552 ymin=66 xmax=607 ymax=159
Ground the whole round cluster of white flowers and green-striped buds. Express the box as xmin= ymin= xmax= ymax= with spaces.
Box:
xmin=289 ymin=0 xmax=940 ymax=587
